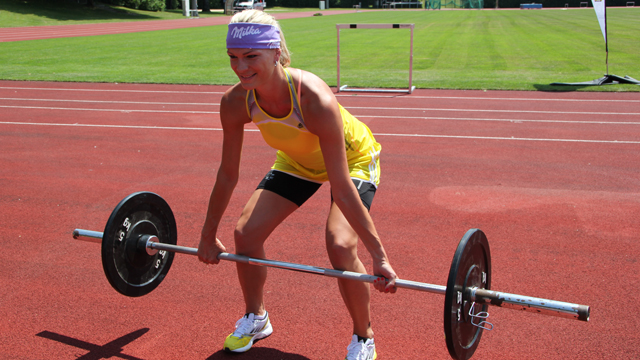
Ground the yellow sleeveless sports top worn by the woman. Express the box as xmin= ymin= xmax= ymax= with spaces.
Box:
xmin=247 ymin=69 xmax=381 ymax=187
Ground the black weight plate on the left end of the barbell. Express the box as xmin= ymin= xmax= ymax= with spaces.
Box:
xmin=102 ymin=192 xmax=178 ymax=297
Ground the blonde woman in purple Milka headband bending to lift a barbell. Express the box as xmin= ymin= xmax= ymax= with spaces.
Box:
xmin=198 ymin=10 xmax=397 ymax=360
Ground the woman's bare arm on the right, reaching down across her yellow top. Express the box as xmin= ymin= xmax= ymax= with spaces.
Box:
xmin=301 ymin=73 xmax=397 ymax=292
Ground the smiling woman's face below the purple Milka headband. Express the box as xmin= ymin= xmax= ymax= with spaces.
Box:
xmin=227 ymin=49 xmax=280 ymax=90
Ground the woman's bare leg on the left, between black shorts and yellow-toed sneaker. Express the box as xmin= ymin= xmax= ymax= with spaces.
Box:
xmin=234 ymin=189 xmax=298 ymax=316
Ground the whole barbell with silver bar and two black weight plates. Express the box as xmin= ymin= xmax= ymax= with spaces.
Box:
xmin=73 ymin=192 xmax=590 ymax=360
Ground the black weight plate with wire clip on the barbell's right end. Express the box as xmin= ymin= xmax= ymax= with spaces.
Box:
xmin=444 ymin=229 xmax=491 ymax=360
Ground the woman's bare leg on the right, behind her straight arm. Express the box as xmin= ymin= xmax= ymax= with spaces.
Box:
xmin=326 ymin=203 xmax=373 ymax=338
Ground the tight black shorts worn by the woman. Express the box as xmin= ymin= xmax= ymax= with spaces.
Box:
xmin=258 ymin=170 xmax=376 ymax=210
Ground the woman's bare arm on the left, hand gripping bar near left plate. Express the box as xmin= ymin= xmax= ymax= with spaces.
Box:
xmin=198 ymin=86 xmax=251 ymax=264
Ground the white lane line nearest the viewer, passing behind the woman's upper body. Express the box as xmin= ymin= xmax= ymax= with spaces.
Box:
xmin=0 ymin=121 xmax=640 ymax=144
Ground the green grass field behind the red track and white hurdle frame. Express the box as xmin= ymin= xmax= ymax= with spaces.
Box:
xmin=0 ymin=4 xmax=640 ymax=91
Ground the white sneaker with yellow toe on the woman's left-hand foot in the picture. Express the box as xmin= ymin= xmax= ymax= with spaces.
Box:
xmin=223 ymin=313 xmax=273 ymax=352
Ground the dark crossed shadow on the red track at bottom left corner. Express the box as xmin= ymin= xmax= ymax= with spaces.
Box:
xmin=36 ymin=328 xmax=149 ymax=360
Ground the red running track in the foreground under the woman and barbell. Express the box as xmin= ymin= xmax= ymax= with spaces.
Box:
xmin=0 ymin=81 xmax=640 ymax=360
